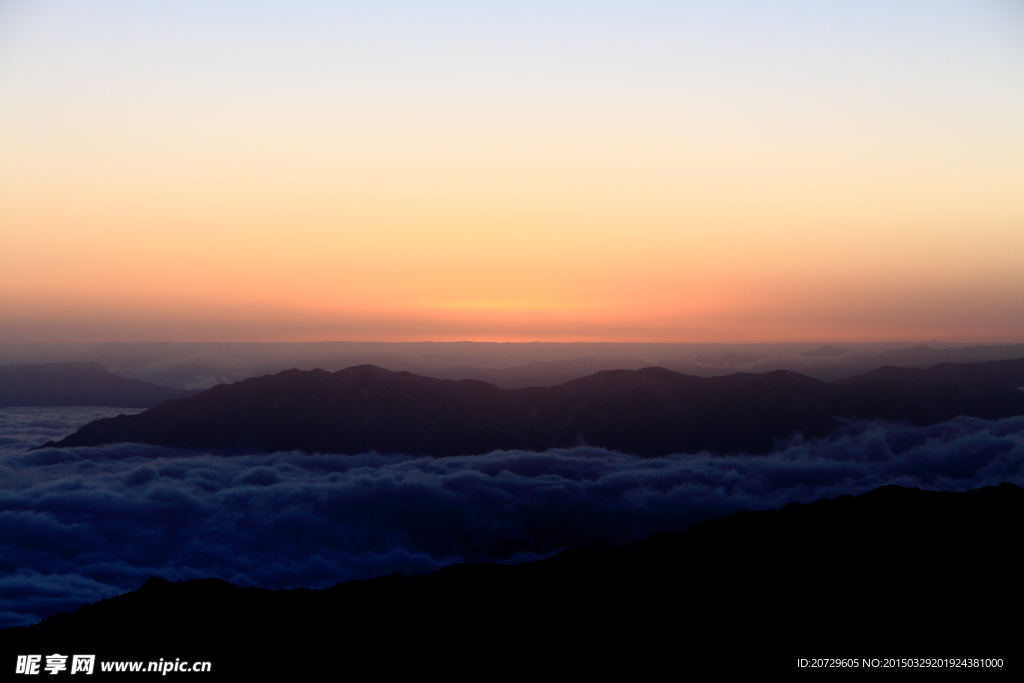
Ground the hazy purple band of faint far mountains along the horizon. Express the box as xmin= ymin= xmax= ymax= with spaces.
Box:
xmin=0 ymin=342 xmax=1024 ymax=389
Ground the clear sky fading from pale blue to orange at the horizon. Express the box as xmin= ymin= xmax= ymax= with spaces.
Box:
xmin=0 ymin=0 xmax=1024 ymax=342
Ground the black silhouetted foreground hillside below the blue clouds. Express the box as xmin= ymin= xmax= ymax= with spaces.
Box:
xmin=0 ymin=483 xmax=1024 ymax=679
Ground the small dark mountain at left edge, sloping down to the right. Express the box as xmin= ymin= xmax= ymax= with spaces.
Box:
xmin=0 ymin=362 xmax=196 ymax=408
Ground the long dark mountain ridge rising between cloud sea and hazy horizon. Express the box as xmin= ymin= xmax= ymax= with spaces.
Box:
xmin=39 ymin=358 xmax=1024 ymax=456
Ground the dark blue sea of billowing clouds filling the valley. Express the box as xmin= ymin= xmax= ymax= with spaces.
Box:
xmin=0 ymin=408 xmax=1024 ymax=627
